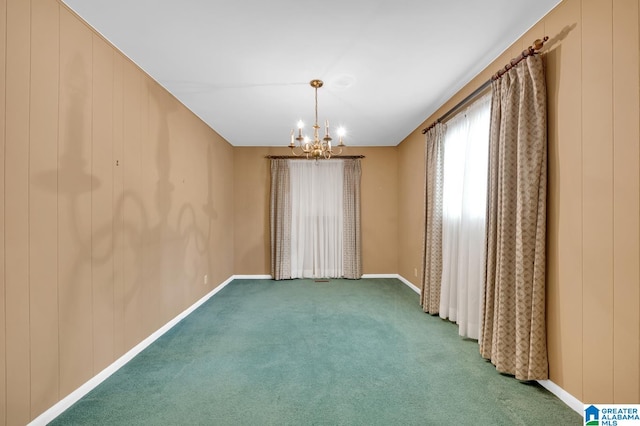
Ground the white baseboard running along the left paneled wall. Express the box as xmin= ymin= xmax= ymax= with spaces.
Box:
xmin=29 ymin=276 xmax=235 ymax=426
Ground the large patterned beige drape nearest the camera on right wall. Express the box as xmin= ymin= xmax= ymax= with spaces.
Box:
xmin=479 ymin=56 xmax=548 ymax=380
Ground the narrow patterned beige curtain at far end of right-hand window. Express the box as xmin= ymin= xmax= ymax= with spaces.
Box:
xmin=420 ymin=123 xmax=445 ymax=315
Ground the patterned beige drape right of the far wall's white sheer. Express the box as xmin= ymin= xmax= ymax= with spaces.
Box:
xmin=342 ymin=158 xmax=362 ymax=279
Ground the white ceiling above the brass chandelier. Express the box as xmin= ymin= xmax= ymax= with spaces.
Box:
xmin=63 ymin=0 xmax=560 ymax=146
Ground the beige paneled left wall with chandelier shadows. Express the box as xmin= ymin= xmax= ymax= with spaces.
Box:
xmin=0 ymin=0 xmax=233 ymax=425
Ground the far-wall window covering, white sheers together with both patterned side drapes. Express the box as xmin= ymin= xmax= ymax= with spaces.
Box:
xmin=271 ymin=159 xmax=362 ymax=279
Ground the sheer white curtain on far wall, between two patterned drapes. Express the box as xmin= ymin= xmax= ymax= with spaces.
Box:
xmin=289 ymin=160 xmax=344 ymax=278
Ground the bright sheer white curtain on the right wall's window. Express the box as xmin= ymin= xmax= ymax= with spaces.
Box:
xmin=440 ymin=95 xmax=491 ymax=339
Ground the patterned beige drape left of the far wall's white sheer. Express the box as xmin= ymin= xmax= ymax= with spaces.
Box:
xmin=270 ymin=158 xmax=291 ymax=280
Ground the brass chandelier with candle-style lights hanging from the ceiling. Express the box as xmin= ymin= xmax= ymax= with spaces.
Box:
xmin=289 ymin=80 xmax=345 ymax=160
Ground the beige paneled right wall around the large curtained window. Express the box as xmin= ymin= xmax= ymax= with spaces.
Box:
xmin=398 ymin=0 xmax=640 ymax=403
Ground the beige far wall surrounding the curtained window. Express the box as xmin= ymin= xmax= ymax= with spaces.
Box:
xmin=234 ymin=147 xmax=398 ymax=275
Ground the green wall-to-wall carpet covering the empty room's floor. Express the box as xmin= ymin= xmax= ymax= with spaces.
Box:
xmin=51 ymin=279 xmax=582 ymax=425
